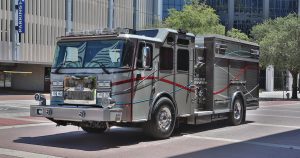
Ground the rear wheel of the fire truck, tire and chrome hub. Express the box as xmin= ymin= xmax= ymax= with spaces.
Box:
xmin=228 ymin=97 xmax=245 ymax=126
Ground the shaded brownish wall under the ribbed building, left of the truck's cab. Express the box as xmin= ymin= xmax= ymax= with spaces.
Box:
xmin=12 ymin=64 xmax=45 ymax=91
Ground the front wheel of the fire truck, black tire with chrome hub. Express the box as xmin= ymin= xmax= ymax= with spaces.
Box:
xmin=144 ymin=98 xmax=175 ymax=139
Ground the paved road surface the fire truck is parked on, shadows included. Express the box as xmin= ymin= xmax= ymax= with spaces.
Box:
xmin=0 ymin=100 xmax=300 ymax=158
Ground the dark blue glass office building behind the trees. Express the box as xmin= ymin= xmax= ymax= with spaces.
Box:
xmin=163 ymin=0 xmax=300 ymax=34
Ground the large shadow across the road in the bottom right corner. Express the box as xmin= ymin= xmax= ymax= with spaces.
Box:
xmin=170 ymin=129 xmax=300 ymax=158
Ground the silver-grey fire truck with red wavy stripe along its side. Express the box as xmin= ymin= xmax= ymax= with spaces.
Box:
xmin=30 ymin=28 xmax=259 ymax=139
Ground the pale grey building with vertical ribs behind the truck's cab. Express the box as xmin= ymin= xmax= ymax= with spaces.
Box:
xmin=0 ymin=0 xmax=162 ymax=91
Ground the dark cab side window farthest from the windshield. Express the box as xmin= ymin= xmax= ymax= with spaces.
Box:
xmin=177 ymin=49 xmax=189 ymax=71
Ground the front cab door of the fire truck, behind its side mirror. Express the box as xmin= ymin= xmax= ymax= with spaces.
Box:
xmin=132 ymin=41 xmax=157 ymax=121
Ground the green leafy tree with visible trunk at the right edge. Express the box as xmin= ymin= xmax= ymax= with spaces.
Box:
xmin=251 ymin=14 xmax=300 ymax=99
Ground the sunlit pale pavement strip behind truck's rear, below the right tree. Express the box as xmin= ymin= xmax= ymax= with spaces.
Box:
xmin=259 ymin=91 xmax=300 ymax=100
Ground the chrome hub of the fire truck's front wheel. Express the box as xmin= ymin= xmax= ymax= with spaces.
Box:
xmin=158 ymin=107 xmax=172 ymax=131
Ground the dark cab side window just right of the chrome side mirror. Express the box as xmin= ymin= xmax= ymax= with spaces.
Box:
xmin=159 ymin=47 xmax=173 ymax=70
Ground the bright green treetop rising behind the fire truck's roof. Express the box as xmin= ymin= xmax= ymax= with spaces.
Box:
xmin=163 ymin=0 xmax=225 ymax=35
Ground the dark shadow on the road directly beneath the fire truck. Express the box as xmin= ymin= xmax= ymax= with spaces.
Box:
xmin=14 ymin=121 xmax=250 ymax=151
